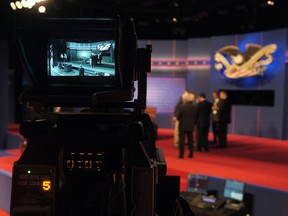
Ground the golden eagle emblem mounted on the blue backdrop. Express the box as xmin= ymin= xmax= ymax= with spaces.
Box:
xmin=214 ymin=44 xmax=277 ymax=79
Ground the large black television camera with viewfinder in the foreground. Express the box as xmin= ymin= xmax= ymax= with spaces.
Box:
xmin=10 ymin=15 xmax=166 ymax=216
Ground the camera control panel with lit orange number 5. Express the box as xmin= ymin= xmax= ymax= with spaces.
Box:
xmin=11 ymin=165 xmax=58 ymax=216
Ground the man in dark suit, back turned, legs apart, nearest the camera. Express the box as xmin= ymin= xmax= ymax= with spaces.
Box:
xmin=176 ymin=92 xmax=196 ymax=158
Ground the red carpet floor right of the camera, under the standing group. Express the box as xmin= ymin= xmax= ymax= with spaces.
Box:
xmin=157 ymin=129 xmax=288 ymax=191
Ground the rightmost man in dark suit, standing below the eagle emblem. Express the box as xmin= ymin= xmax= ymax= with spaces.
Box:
xmin=218 ymin=91 xmax=232 ymax=148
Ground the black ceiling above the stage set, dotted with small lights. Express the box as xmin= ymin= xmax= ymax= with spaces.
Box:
xmin=0 ymin=0 xmax=288 ymax=39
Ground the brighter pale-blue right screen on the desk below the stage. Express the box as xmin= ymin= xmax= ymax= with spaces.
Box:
xmin=224 ymin=179 xmax=245 ymax=201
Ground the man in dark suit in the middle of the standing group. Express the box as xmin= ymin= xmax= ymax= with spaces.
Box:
xmin=196 ymin=93 xmax=212 ymax=151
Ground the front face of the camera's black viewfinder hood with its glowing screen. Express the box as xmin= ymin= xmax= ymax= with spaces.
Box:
xmin=17 ymin=17 xmax=119 ymax=88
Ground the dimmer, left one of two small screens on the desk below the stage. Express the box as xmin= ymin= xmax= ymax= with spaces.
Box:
xmin=187 ymin=174 xmax=208 ymax=194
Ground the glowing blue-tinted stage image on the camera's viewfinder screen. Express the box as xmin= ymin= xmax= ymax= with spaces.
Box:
xmin=47 ymin=39 xmax=116 ymax=77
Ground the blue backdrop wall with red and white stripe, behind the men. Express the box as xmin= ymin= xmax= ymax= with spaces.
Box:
xmin=138 ymin=29 xmax=288 ymax=139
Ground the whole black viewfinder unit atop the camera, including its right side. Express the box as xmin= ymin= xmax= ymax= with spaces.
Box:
xmin=16 ymin=16 xmax=137 ymax=106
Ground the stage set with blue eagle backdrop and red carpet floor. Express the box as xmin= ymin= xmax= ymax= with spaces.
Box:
xmin=0 ymin=23 xmax=288 ymax=216
